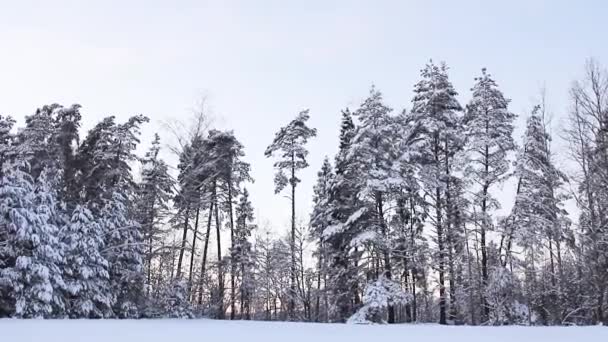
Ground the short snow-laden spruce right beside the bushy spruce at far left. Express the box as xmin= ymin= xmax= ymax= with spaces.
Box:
xmin=61 ymin=205 xmax=114 ymax=318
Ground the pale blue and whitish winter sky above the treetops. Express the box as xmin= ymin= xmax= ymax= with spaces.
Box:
xmin=0 ymin=0 xmax=608 ymax=231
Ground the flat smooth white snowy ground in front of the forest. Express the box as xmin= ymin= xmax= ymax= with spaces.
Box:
xmin=0 ymin=319 xmax=608 ymax=342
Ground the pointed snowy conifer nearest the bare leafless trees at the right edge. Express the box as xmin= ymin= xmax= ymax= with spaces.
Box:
xmin=506 ymin=106 xmax=567 ymax=323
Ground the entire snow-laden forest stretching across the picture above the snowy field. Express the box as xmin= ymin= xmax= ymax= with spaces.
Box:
xmin=0 ymin=59 xmax=608 ymax=325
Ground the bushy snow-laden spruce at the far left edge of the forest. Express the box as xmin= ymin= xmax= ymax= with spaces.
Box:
xmin=0 ymin=161 xmax=65 ymax=318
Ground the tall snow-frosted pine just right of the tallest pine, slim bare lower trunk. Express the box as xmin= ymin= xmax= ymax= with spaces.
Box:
xmin=464 ymin=68 xmax=515 ymax=319
